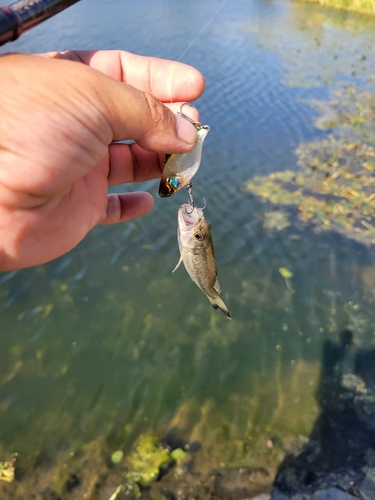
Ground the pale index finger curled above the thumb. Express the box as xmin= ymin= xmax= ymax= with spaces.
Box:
xmin=41 ymin=50 xmax=205 ymax=102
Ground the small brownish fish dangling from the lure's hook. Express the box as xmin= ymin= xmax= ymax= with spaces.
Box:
xmin=173 ymin=203 xmax=232 ymax=319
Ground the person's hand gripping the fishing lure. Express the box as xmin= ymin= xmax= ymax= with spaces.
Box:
xmin=0 ymin=51 xmax=204 ymax=271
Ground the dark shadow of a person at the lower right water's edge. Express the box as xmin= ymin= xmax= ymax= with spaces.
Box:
xmin=273 ymin=329 xmax=375 ymax=499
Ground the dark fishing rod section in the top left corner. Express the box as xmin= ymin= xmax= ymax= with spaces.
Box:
xmin=0 ymin=0 xmax=79 ymax=45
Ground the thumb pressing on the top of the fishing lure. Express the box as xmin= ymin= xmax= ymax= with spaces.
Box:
xmin=9 ymin=55 xmax=197 ymax=153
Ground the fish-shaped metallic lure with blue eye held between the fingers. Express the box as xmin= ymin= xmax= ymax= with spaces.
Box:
xmin=159 ymin=124 xmax=210 ymax=198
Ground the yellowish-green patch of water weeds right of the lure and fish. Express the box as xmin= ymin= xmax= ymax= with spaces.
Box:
xmin=247 ymin=84 xmax=375 ymax=244
